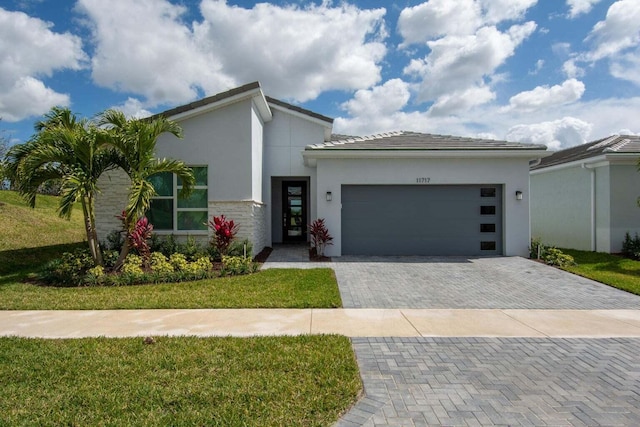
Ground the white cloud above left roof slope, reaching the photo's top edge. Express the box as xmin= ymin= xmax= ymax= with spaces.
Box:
xmin=78 ymin=0 xmax=235 ymax=105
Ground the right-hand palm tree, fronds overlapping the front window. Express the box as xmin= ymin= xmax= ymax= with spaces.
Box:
xmin=98 ymin=110 xmax=195 ymax=269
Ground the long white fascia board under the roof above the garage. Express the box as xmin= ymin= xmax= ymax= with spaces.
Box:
xmin=302 ymin=149 xmax=551 ymax=167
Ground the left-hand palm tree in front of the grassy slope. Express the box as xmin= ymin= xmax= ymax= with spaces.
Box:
xmin=5 ymin=107 xmax=117 ymax=265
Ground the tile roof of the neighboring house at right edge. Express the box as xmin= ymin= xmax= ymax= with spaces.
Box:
xmin=531 ymin=135 xmax=640 ymax=170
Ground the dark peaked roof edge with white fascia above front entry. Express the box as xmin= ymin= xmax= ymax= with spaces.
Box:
xmin=152 ymin=82 xmax=333 ymax=124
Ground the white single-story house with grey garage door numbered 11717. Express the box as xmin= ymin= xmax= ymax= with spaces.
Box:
xmin=96 ymin=83 xmax=547 ymax=256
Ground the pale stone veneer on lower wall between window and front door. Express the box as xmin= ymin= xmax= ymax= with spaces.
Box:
xmin=209 ymin=200 xmax=267 ymax=255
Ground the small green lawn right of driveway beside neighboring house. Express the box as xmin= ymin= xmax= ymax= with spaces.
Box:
xmin=562 ymin=249 xmax=640 ymax=295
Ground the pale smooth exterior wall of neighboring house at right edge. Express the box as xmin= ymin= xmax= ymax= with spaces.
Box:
xmin=531 ymin=162 xmax=640 ymax=253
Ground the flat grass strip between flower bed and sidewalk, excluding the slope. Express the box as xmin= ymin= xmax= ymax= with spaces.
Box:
xmin=0 ymin=268 xmax=342 ymax=310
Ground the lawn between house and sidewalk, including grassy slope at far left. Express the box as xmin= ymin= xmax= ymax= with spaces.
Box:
xmin=0 ymin=191 xmax=342 ymax=310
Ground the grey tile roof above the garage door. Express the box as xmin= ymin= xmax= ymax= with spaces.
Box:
xmin=306 ymin=131 xmax=547 ymax=150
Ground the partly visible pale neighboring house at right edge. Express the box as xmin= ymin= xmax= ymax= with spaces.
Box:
xmin=531 ymin=135 xmax=640 ymax=253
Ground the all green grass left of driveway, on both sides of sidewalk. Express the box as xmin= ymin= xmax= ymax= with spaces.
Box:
xmin=0 ymin=191 xmax=362 ymax=426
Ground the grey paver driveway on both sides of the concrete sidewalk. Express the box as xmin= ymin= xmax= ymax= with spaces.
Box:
xmin=262 ymin=251 xmax=640 ymax=427
